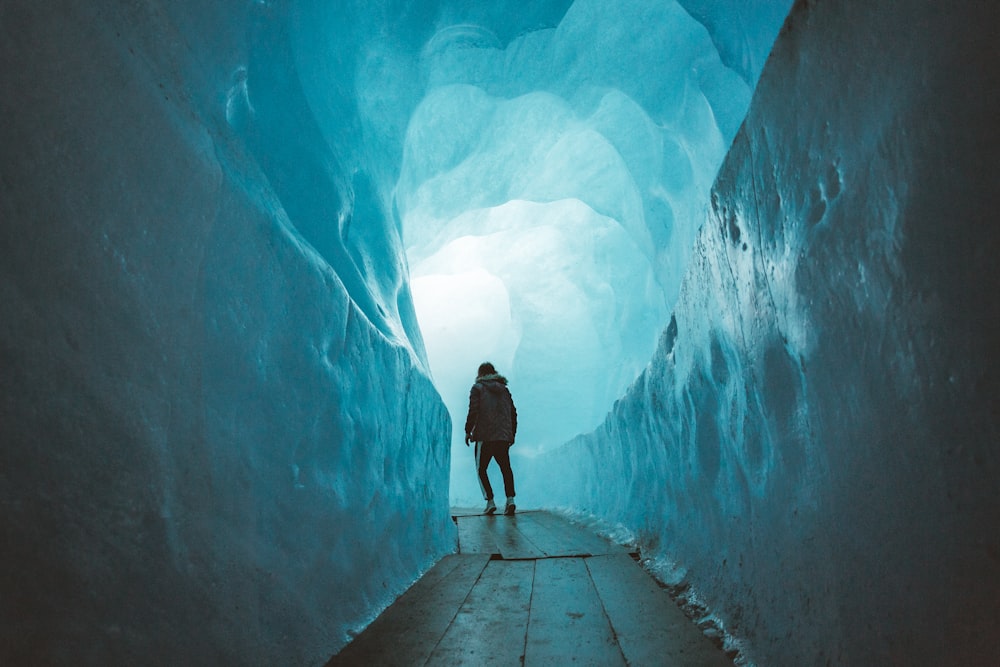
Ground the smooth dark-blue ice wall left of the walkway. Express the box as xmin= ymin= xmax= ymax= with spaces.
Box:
xmin=0 ymin=2 xmax=454 ymax=665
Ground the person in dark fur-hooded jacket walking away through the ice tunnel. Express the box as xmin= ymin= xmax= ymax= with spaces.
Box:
xmin=465 ymin=361 xmax=517 ymax=515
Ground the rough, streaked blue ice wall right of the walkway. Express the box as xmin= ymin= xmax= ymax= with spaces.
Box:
xmin=536 ymin=0 xmax=1000 ymax=665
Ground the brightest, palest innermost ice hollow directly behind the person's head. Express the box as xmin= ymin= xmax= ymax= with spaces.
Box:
xmin=413 ymin=199 xmax=665 ymax=502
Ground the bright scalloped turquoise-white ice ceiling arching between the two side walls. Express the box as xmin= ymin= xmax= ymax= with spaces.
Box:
xmin=280 ymin=0 xmax=791 ymax=500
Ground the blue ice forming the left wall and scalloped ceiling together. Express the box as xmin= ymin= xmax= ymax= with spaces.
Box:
xmin=0 ymin=0 xmax=792 ymax=664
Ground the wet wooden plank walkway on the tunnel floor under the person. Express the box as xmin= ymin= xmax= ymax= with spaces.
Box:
xmin=327 ymin=509 xmax=733 ymax=667
